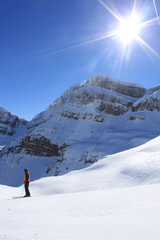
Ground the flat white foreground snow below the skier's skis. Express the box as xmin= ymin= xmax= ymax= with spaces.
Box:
xmin=0 ymin=183 xmax=160 ymax=240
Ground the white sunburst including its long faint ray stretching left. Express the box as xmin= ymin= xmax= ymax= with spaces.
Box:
xmin=31 ymin=0 xmax=160 ymax=73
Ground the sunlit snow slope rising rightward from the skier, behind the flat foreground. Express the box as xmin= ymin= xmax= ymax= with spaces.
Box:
xmin=28 ymin=137 xmax=160 ymax=195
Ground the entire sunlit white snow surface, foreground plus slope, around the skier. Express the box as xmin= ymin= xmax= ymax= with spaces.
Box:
xmin=0 ymin=137 xmax=160 ymax=240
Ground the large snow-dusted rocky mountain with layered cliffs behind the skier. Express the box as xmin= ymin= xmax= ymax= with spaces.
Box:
xmin=0 ymin=74 xmax=160 ymax=185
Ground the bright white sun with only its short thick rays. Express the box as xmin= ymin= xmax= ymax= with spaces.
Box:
xmin=97 ymin=0 xmax=160 ymax=72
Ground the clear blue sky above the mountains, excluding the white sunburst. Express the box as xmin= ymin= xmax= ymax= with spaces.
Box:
xmin=0 ymin=0 xmax=160 ymax=120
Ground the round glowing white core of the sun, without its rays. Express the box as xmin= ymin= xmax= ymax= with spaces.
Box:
xmin=118 ymin=14 xmax=141 ymax=44
